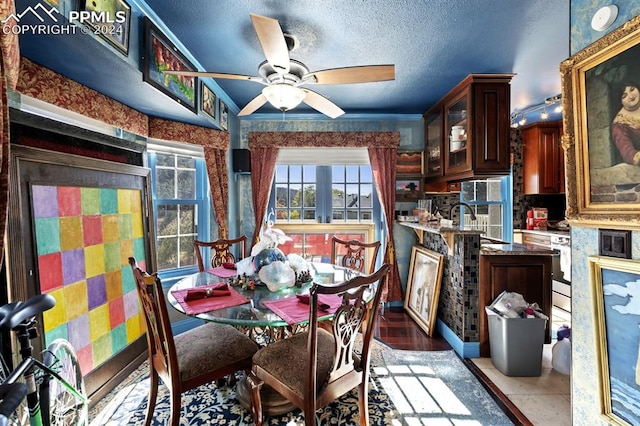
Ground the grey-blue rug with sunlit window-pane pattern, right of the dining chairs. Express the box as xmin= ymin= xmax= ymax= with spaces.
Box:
xmin=375 ymin=349 xmax=513 ymax=426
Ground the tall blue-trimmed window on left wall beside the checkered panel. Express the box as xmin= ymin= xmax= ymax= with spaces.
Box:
xmin=149 ymin=146 xmax=211 ymax=271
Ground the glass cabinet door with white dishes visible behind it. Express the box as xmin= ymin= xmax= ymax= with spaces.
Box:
xmin=444 ymin=91 xmax=472 ymax=174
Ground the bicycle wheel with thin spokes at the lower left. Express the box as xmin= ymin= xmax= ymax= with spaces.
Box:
xmin=40 ymin=339 xmax=89 ymax=426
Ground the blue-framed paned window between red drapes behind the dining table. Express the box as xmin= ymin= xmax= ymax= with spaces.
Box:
xmin=269 ymin=164 xmax=380 ymax=223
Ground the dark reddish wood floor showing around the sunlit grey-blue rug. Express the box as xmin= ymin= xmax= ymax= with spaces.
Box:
xmin=375 ymin=307 xmax=532 ymax=426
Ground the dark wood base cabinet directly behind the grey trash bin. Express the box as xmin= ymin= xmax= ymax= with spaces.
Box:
xmin=478 ymin=253 xmax=553 ymax=357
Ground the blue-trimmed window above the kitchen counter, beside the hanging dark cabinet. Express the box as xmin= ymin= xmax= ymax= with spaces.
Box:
xmin=460 ymin=176 xmax=513 ymax=241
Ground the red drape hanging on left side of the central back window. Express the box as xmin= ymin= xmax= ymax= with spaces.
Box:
xmin=251 ymin=147 xmax=279 ymax=247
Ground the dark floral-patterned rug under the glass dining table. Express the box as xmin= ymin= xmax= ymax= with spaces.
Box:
xmin=89 ymin=341 xmax=399 ymax=426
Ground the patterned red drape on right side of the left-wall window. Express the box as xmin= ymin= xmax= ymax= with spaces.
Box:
xmin=203 ymin=145 xmax=229 ymax=238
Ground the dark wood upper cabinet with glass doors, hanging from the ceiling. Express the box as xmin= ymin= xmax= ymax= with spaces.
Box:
xmin=424 ymin=74 xmax=513 ymax=188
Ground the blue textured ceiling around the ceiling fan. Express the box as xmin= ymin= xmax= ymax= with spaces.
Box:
xmin=16 ymin=0 xmax=570 ymax=125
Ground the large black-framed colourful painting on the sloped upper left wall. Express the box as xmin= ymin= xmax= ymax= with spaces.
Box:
xmin=142 ymin=18 xmax=198 ymax=113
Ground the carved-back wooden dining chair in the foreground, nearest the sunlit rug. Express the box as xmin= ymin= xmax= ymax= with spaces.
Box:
xmin=247 ymin=264 xmax=389 ymax=426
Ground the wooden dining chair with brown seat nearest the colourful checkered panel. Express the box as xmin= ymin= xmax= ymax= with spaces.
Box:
xmin=129 ymin=257 xmax=258 ymax=426
